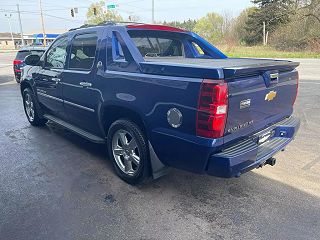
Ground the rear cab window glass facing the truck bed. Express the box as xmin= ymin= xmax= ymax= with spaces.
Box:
xmin=129 ymin=31 xmax=184 ymax=57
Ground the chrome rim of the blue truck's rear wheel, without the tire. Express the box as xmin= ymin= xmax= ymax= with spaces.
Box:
xmin=112 ymin=129 xmax=140 ymax=176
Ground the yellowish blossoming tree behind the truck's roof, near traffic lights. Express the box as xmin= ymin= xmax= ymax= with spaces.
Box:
xmin=86 ymin=1 xmax=123 ymax=25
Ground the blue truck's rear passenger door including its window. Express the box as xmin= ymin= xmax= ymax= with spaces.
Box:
xmin=61 ymin=32 xmax=100 ymax=134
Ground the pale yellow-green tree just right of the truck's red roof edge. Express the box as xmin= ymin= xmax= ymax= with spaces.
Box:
xmin=193 ymin=12 xmax=224 ymax=43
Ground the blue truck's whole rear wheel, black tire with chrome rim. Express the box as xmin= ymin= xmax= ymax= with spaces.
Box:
xmin=107 ymin=119 xmax=150 ymax=185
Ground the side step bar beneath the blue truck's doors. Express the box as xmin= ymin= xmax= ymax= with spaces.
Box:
xmin=43 ymin=114 xmax=106 ymax=143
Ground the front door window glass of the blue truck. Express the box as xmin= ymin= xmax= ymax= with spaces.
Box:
xmin=45 ymin=37 xmax=68 ymax=68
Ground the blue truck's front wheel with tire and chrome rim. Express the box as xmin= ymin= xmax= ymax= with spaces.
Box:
xmin=22 ymin=88 xmax=47 ymax=126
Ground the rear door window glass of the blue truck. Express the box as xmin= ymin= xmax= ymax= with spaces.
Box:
xmin=69 ymin=33 xmax=98 ymax=70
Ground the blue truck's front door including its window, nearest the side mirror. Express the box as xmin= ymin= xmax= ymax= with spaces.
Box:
xmin=33 ymin=36 xmax=68 ymax=118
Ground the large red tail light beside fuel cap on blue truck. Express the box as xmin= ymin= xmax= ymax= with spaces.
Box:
xmin=196 ymin=80 xmax=228 ymax=138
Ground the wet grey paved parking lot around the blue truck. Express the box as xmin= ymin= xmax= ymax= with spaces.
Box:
xmin=0 ymin=53 xmax=320 ymax=240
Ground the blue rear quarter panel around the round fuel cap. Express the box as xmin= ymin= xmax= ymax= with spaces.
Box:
xmin=96 ymin=68 xmax=220 ymax=172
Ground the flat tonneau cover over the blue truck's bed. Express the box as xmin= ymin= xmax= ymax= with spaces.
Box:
xmin=140 ymin=57 xmax=299 ymax=79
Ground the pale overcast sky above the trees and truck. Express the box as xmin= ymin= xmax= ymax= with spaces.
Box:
xmin=0 ymin=0 xmax=251 ymax=33
